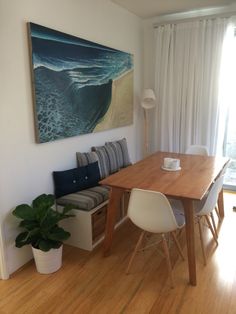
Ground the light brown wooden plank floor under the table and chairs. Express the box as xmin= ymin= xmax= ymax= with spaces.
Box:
xmin=0 ymin=193 xmax=236 ymax=314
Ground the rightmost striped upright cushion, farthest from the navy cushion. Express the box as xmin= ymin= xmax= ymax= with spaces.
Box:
xmin=105 ymin=138 xmax=131 ymax=168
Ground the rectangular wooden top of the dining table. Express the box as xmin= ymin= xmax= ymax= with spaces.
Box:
xmin=100 ymin=152 xmax=229 ymax=200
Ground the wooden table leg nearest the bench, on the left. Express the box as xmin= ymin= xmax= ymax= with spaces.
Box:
xmin=103 ymin=187 xmax=124 ymax=256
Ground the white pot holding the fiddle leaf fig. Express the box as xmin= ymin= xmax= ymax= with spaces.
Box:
xmin=32 ymin=245 xmax=62 ymax=274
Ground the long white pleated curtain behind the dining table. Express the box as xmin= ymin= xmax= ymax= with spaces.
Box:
xmin=154 ymin=18 xmax=228 ymax=154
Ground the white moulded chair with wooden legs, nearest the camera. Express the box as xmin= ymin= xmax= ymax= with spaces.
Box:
xmin=126 ymin=189 xmax=185 ymax=287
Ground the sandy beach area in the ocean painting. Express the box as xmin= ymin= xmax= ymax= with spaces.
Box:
xmin=93 ymin=70 xmax=133 ymax=132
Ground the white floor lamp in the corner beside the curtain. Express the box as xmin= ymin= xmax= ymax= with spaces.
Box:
xmin=141 ymin=88 xmax=156 ymax=156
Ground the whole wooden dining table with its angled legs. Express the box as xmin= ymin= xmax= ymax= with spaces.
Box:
xmin=100 ymin=152 xmax=229 ymax=286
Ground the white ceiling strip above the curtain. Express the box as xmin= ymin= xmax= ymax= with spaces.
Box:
xmin=111 ymin=0 xmax=234 ymax=18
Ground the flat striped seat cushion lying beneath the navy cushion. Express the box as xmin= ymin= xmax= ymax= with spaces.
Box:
xmin=56 ymin=186 xmax=109 ymax=211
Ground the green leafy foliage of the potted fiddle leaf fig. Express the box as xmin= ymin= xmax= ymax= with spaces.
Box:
xmin=12 ymin=194 xmax=74 ymax=252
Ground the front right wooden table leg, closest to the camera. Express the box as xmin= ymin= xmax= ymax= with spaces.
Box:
xmin=182 ymin=199 xmax=197 ymax=286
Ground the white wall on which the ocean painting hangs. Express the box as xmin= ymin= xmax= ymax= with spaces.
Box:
xmin=0 ymin=0 xmax=142 ymax=274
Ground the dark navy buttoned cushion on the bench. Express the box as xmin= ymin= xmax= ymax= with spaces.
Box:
xmin=53 ymin=162 xmax=100 ymax=198
